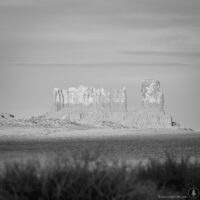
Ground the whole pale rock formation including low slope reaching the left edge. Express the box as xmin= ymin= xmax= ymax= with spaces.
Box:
xmin=0 ymin=79 xmax=184 ymax=131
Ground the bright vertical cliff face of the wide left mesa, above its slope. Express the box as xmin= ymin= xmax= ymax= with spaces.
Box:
xmin=54 ymin=86 xmax=127 ymax=110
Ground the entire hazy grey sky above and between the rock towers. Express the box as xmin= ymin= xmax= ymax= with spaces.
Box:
xmin=0 ymin=0 xmax=200 ymax=130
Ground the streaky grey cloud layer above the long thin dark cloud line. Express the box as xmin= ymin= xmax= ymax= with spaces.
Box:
xmin=0 ymin=0 xmax=200 ymax=63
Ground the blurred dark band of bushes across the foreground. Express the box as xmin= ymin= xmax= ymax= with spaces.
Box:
xmin=0 ymin=151 xmax=200 ymax=200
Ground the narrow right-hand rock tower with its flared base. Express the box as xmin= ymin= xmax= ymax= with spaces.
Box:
xmin=134 ymin=79 xmax=172 ymax=129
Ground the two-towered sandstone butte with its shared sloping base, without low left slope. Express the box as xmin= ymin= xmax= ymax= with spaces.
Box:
xmin=49 ymin=79 xmax=176 ymax=129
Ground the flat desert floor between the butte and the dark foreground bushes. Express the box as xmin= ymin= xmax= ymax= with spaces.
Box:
xmin=0 ymin=127 xmax=200 ymax=163
